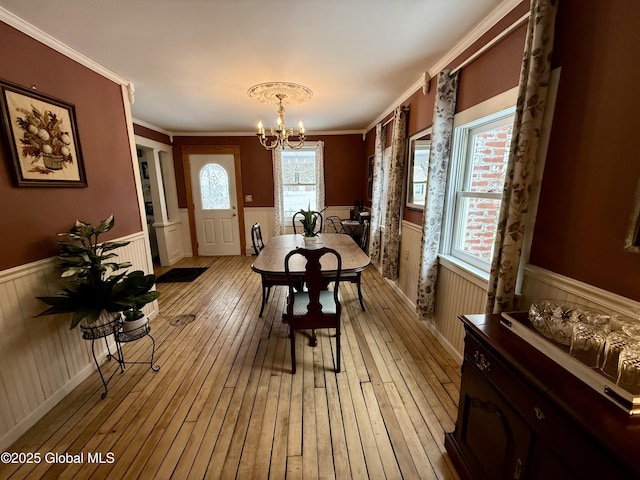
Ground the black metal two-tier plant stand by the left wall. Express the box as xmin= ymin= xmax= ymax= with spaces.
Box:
xmin=81 ymin=316 xmax=160 ymax=399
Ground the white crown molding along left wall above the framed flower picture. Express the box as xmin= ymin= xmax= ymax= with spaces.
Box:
xmin=0 ymin=7 xmax=133 ymax=86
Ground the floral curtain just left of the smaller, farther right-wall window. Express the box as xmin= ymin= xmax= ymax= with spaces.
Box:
xmin=382 ymin=107 xmax=409 ymax=280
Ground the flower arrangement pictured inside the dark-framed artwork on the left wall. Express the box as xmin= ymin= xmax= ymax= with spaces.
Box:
xmin=16 ymin=106 xmax=73 ymax=170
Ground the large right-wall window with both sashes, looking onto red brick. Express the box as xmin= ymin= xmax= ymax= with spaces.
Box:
xmin=449 ymin=108 xmax=514 ymax=272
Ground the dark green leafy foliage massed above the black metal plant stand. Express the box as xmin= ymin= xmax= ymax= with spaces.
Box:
xmin=36 ymin=215 xmax=160 ymax=328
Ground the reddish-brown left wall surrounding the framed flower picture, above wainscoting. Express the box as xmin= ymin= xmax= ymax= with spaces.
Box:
xmin=0 ymin=22 xmax=141 ymax=270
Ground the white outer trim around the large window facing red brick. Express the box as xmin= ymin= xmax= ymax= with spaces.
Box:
xmin=440 ymin=87 xmax=518 ymax=281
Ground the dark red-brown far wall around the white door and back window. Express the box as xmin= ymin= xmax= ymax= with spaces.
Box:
xmin=173 ymin=134 xmax=367 ymax=208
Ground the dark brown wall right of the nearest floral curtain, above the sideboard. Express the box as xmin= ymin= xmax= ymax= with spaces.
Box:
xmin=530 ymin=0 xmax=640 ymax=300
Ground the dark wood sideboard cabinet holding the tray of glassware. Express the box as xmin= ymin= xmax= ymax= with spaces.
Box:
xmin=445 ymin=315 xmax=640 ymax=480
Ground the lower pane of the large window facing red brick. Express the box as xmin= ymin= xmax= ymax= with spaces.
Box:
xmin=455 ymin=197 xmax=500 ymax=262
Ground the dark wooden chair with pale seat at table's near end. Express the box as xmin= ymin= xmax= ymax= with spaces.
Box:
xmin=284 ymin=247 xmax=342 ymax=374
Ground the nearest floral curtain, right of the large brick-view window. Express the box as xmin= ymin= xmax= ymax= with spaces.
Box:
xmin=485 ymin=0 xmax=558 ymax=313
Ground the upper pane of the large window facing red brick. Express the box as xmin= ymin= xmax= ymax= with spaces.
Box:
xmin=468 ymin=124 xmax=513 ymax=192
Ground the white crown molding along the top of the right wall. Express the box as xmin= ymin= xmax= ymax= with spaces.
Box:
xmin=361 ymin=0 xmax=522 ymax=136
